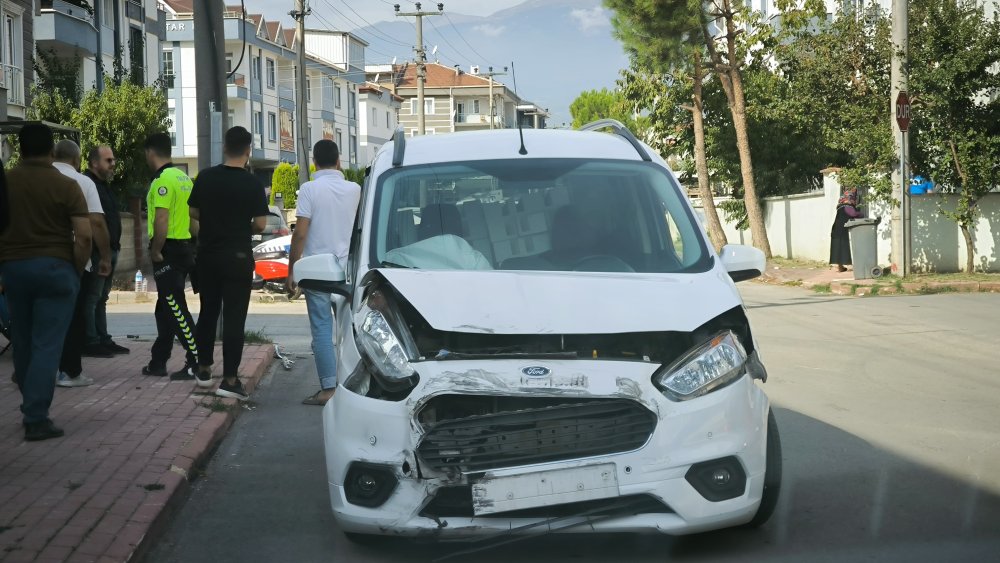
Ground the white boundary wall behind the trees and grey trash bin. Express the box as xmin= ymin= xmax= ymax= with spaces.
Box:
xmin=693 ymin=173 xmax=1000 ymax=272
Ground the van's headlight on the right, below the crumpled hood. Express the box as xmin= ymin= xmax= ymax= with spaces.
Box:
xmin=653 ymin=330 xmax=747 ymax=401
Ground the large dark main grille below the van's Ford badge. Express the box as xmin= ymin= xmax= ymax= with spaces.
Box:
xmin=417 ymin=399 xmax=656 ymax=473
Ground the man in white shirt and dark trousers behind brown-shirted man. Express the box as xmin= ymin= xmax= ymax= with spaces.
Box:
xmin=52 ymin=139 xmax=112 ymax=387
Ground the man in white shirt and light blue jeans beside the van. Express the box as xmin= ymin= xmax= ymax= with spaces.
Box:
xmin=288 ymin=139 xmax=361 ymax=405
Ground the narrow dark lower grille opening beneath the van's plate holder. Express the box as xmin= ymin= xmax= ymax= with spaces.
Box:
xmin=420 ymin=485 xmax=673 ymax=518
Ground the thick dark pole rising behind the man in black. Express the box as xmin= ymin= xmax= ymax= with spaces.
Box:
xmin=194 ymin=0 xmax=229 ymax=170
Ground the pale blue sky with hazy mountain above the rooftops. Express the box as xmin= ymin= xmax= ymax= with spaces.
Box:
xmin=243 ymin=0 xmax=628 ymax=127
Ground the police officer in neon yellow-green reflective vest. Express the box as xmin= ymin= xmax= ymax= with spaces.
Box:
xmin=142 ymin=133 xmax=198 ymax=380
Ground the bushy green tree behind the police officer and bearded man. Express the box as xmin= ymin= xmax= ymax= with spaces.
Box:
xmin=71 ymin=78 xmax=170 ymax=196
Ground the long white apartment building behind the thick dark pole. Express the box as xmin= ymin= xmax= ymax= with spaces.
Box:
xmin=160 ymin=0 xmax=367 ymax=176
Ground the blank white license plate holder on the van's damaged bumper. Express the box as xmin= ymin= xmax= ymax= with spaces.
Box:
xmin=472 ymin=463 xmax=620 ymax=516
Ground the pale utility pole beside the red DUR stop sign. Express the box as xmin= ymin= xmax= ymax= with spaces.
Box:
xmin=887 ymin=0 xmax=910 ymax=277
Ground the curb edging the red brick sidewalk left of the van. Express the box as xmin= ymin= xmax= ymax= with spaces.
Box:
xmin=131 ymin=344 xmax=275 ymax=562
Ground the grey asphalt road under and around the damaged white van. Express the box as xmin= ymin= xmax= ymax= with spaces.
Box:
xmin=139 ymin=283 xmax=1000 ymax=563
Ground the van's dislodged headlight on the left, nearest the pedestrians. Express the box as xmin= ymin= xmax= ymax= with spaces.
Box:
xmin=356 ymin=291 xmax=416 ymax=391
